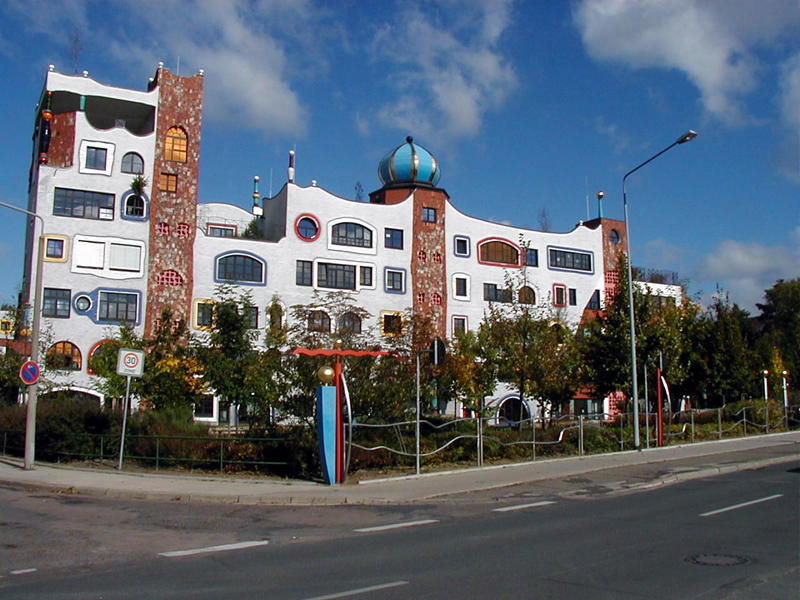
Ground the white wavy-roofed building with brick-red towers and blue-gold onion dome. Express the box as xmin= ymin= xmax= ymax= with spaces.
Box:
xmin=17 ymin=65 xmax=664 ymax=420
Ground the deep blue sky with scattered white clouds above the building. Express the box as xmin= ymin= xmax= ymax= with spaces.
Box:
xmin=0 ymin=0 xmax=800 ymax=314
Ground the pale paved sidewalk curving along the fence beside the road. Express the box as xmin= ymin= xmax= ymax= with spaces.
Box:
xmin=0 ymin=431 xmax=800 ymax=505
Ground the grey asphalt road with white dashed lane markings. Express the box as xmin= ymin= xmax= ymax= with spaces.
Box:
xmin=0 ymin=461 xmax=800 ymax=600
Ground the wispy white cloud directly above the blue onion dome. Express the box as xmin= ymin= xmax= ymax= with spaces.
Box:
xmin=372 ymin=0 xmax=517 ymax=138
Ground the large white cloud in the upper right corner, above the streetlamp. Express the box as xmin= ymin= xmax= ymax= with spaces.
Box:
xmin=574 ymin=0 xmax=800 ymax=123
